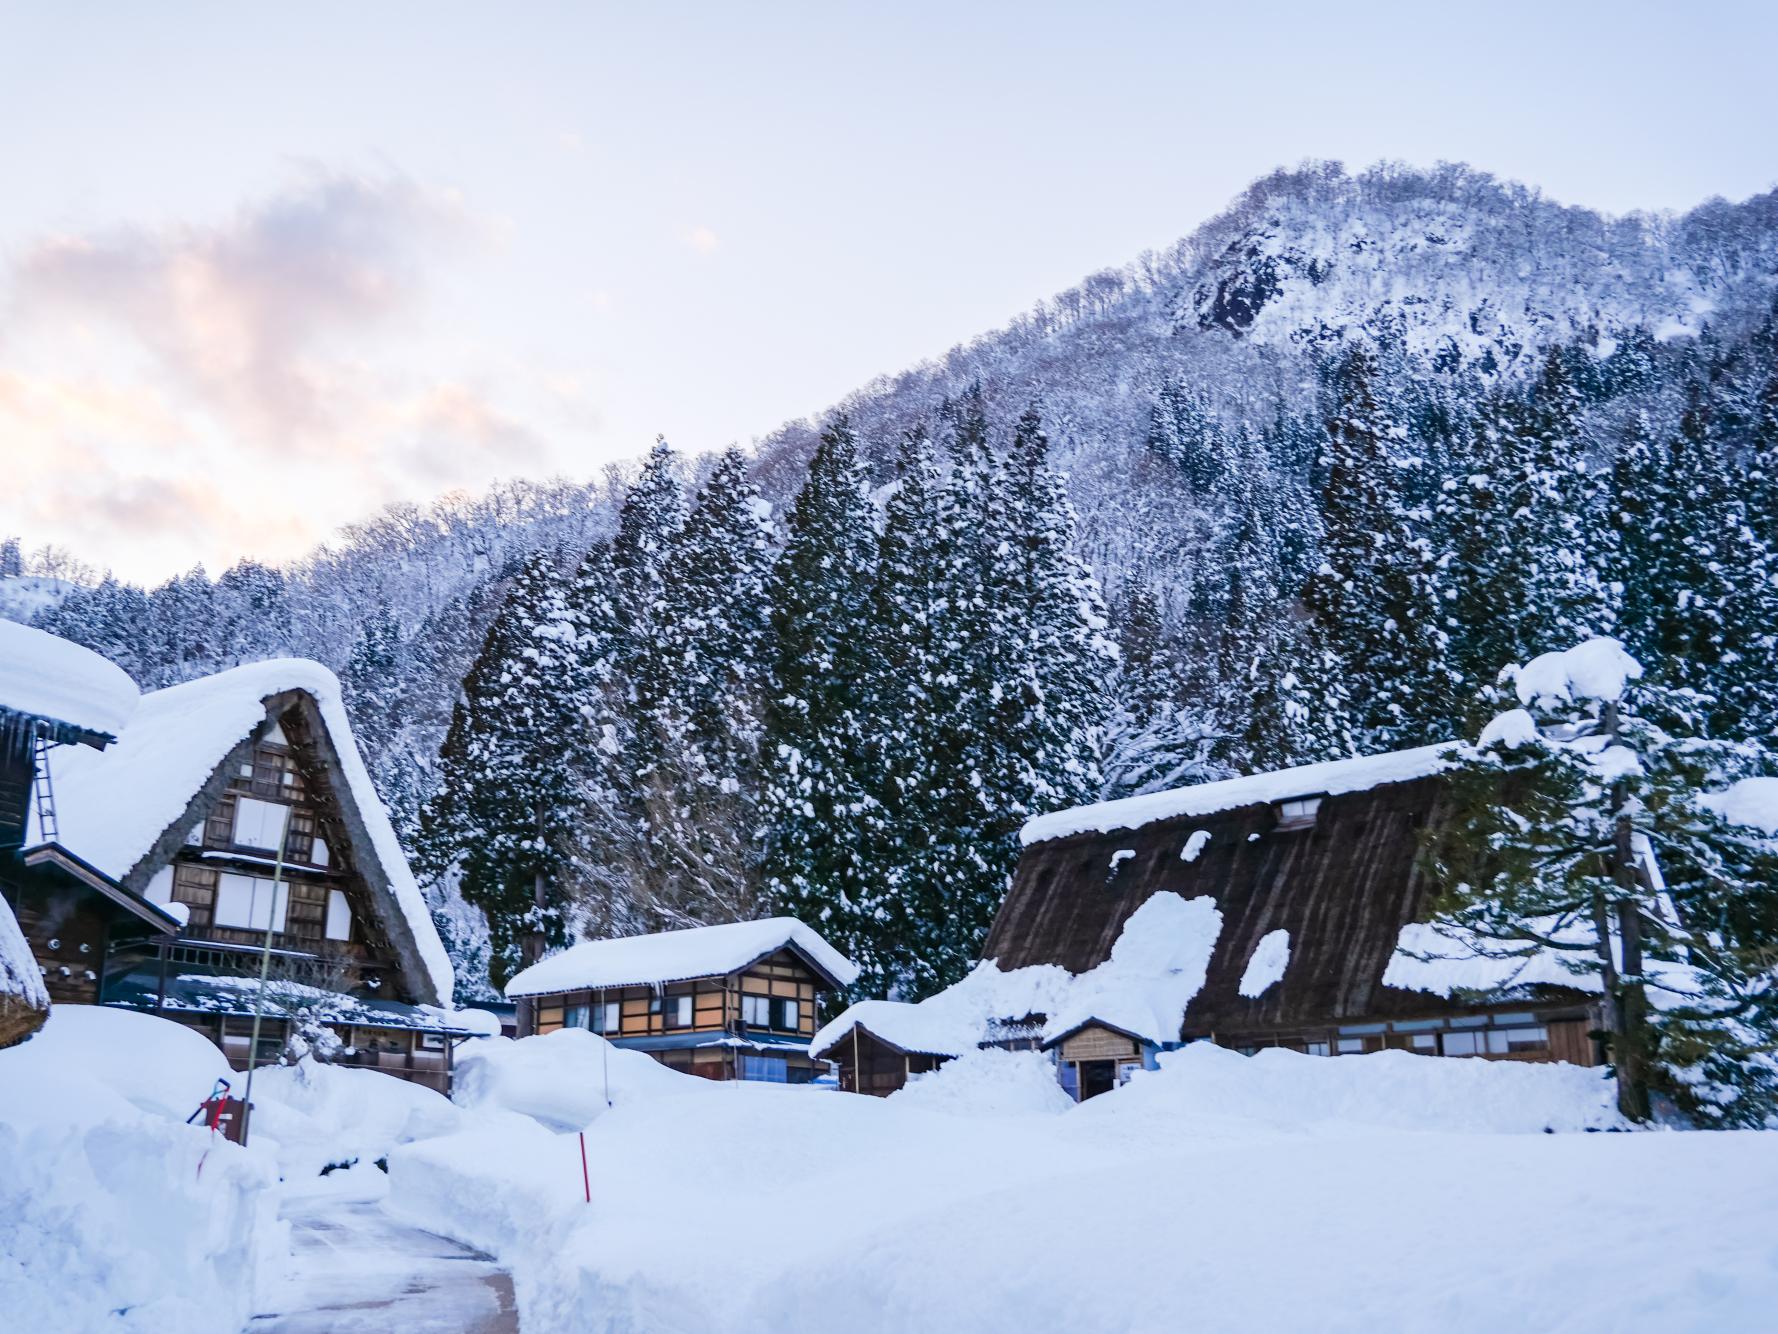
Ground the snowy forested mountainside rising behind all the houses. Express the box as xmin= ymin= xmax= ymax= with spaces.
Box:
xmin=10 ymin=164 xmax=1778 ymax=1024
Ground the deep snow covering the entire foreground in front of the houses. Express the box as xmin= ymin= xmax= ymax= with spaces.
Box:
xmin=0 ymin=1007 xmax=1778 ymax=1334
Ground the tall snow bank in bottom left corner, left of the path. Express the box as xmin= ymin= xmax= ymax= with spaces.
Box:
xmin=0 ymin=1005 xmax=283 ymax=1334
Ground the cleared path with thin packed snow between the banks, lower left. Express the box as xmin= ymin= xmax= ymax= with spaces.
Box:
xmin=247 ymin=1169 xmax=519 ymax=1334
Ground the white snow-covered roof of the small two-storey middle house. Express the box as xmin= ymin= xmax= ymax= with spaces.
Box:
xmin=507 ymin=918 xmax=859 ymax=1000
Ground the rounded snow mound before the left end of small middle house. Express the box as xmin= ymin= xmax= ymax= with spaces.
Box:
xmin=452 ymin=1028 xmax=686 ymax=1129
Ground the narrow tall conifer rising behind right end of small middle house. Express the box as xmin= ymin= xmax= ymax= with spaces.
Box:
xmin=759 ymin=416 xmax=877 ymax=967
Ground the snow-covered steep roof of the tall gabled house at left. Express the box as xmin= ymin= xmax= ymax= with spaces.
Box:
xmin=32 ymin=658 xmax=452 ymax=1001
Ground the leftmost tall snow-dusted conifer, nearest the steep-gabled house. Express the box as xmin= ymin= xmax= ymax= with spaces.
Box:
xmin=420 ymin=551 xmax=587 ymax=1024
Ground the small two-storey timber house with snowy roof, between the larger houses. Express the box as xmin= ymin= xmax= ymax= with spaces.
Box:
xmin=507 ymin=918 xmax=859 ymax=1083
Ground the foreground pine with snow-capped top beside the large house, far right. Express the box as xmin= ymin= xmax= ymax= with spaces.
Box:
xmin=1428 ymin=639 xmax=1778 ymax=1126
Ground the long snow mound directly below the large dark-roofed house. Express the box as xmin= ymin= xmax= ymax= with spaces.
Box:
xmin=1081 ymin=1042 xmax=1625 ymax=1135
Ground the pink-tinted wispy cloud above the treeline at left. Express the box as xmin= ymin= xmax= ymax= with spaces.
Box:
xmin=0 ymin=169 xmax=568 ymax=575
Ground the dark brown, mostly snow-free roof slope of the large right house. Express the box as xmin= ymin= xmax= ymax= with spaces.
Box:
xmin=983 ymin=779 xmax=1442 ymax=1033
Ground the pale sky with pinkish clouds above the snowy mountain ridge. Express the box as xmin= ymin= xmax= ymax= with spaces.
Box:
xmin=0 ymin=0 xmax=1778 ymax=580
